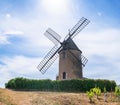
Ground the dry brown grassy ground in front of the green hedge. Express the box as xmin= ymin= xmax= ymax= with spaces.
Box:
xmin=0 ymin=89 xmax=120 ymax=105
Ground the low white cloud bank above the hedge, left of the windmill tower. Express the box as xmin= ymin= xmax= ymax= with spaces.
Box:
xmin=0 ymin=56 xmax=57 ymax=87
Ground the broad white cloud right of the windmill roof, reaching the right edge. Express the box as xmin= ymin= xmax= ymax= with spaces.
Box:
xmin=75 ymin=28 xmax=120 ymax=58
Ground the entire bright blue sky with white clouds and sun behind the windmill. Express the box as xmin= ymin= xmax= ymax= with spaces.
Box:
xmin=0 ymin=0 xmax=120 ymax=87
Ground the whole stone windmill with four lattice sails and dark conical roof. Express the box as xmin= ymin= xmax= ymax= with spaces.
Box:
xmin=37 ymin=17 xmax=90 ymax=80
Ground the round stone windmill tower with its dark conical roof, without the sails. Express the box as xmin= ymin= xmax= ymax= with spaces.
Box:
xmin=58 ymin=38 xmax=83 ymax=80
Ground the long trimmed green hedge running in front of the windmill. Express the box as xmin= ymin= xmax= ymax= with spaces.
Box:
xmin=5 ymin=78 xmax=116 ymax=92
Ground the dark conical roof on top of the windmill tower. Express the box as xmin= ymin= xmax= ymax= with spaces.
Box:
xmin=61 ymin=38 xmax=82 ymax=52
